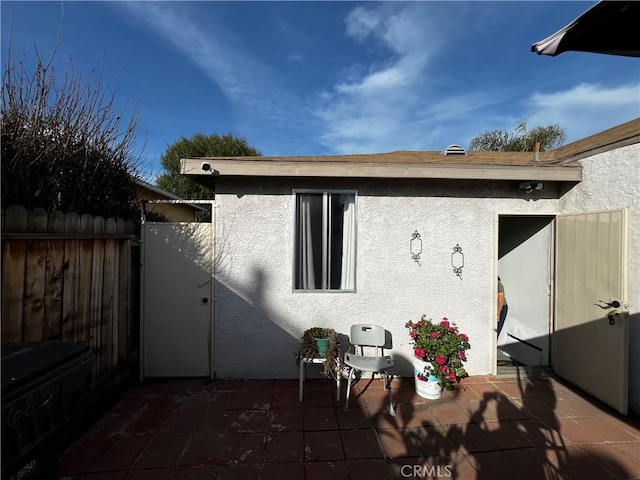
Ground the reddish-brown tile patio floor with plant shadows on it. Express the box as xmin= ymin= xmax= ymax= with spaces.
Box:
xmin=59 ymin=376 xmax=640 ymax=480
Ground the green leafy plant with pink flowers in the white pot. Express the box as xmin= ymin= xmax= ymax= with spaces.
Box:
xmin=405 ymin=315 xmax=470 ymax=390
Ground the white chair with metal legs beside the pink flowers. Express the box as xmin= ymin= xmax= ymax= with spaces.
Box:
xmin=344 ymin=324 xmax=396 ymax=416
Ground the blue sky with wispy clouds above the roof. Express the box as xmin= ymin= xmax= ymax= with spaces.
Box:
xmin=1 ymin=1 xmax=640 ymax=181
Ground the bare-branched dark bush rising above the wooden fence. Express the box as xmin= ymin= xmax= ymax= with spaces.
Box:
xmin=0 ymin=42 xmax=140 ymax=219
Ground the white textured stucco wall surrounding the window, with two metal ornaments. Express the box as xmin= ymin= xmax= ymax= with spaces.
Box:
xmin=215 ymin=178 xmax=558 ymax=378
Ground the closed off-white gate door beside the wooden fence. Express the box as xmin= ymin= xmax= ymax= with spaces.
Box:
xmin=142 ymin=223 xmax=214 ymax=378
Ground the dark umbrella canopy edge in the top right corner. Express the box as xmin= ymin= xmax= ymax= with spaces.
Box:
xmin=531 ymin=0 xmax=640 ymax=57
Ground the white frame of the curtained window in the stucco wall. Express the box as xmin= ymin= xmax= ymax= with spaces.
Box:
xmin=291 ymin=188 xmax=358 ymax=293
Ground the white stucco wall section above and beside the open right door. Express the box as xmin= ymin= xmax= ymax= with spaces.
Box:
xmin=560 ymin=144 xmax=640 ymax=413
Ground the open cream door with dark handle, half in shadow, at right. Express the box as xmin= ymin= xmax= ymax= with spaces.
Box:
xmin=551 ymin=210 xmax=629 ymax=414
